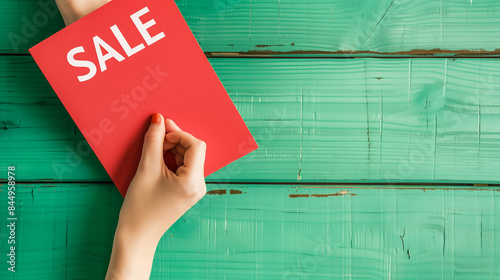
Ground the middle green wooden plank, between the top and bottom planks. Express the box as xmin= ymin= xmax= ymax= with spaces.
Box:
xmin=0 ymin=56 xmax=500 ymax=184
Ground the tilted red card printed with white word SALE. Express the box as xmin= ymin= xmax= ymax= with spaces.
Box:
xmin=29 ymin=0 xmax=257 ymax=196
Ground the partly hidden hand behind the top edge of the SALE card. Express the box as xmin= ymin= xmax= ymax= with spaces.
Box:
xmin=56 ymin=0 xmax=110 ymax=26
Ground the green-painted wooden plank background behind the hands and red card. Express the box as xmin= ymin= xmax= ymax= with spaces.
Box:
xmin=0 ymin=0 xmax=500 ymax=280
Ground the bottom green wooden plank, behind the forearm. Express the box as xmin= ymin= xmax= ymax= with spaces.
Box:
xmin=0 ymin=184 xmax=500 ymax=280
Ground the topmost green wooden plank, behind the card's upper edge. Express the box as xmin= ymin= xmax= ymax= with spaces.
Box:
xmin=0 ymin=0 xmax=500 ymax=55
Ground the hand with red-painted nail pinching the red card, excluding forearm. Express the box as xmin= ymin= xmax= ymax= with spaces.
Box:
xmin=117 ymin=114 xmax=206 ymax=244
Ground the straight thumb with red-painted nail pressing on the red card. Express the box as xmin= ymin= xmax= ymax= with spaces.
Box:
xmin=139 ymin=113 xmax=165 ymax=170
